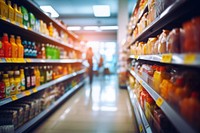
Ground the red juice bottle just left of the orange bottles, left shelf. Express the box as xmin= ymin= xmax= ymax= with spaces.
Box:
xmin=2 ymin=33 xmax=12 ymax=58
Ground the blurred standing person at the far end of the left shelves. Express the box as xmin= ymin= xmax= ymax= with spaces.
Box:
xmin=86 ymin=47 xmax=94 ymax=85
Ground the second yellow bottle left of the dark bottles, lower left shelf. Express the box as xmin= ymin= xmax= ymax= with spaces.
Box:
xmin=8 ymin=70 xmax=17 ymax=95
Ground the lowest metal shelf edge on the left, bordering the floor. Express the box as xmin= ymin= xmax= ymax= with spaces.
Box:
xmin=15 ymin=81 xmax=85 ymax=133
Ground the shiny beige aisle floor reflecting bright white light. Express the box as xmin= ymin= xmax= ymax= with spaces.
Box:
xmin=33 ymin=76 xmax=137 ymax=133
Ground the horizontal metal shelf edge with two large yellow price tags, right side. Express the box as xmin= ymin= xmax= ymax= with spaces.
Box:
xmin=129 ymin=54 xmax=200 ymax=66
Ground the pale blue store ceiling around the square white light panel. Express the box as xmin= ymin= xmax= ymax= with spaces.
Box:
xmin=34 ymin=0 xmax=137 ymax=39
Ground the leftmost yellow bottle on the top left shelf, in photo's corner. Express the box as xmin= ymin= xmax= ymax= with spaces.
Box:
xmin=0 ymin=0 xmax=8 ymax=19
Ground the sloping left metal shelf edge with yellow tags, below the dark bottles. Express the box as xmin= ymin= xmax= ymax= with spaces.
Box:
xmin=0 ymin=69 xmax=85 ymax=106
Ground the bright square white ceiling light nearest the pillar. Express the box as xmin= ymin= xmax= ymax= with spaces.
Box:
xmin=93 ymin=5 xmax=110 ymax=17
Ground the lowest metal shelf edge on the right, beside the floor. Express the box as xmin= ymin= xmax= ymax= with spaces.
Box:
xmin=127 ymin=86 xmax=152 ymax=133
